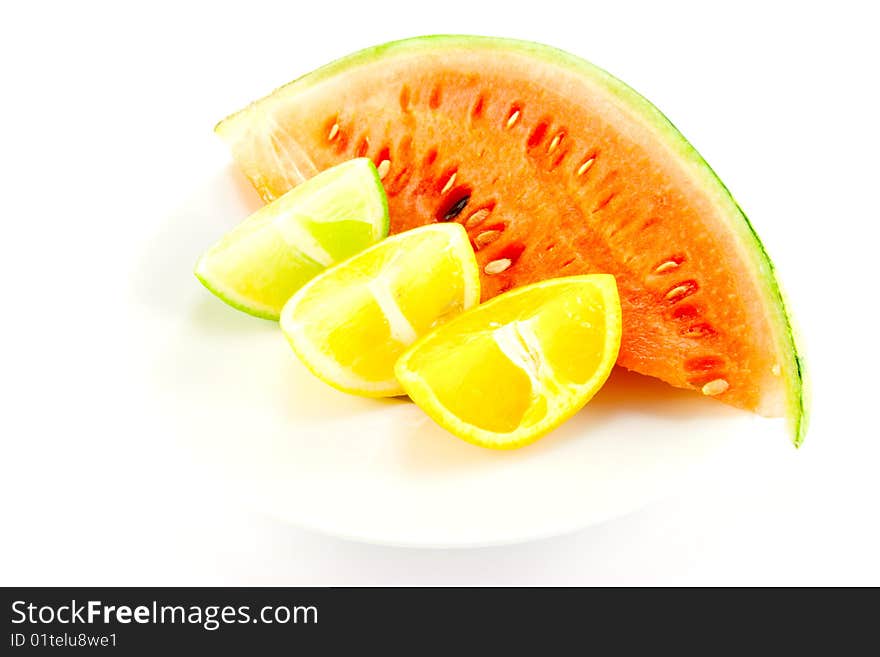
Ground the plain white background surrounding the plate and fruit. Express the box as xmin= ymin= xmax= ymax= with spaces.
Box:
xmin=0 ymin=0 xmax=880 ymax=585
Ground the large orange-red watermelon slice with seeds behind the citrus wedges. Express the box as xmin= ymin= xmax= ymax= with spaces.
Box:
xmin=216 ymin=36 xmax=806 ymax=444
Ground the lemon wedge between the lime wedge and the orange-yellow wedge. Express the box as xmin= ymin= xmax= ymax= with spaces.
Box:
xmin=281 ymin=223 xmax=480 ymax=397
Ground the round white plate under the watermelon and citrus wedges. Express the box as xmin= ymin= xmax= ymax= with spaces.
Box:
xmin=139 ymin=161 xmax=784 ymax=547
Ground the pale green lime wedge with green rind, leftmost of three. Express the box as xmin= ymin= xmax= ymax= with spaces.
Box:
xmin=195 ymin=158 xmax=388 ymax=319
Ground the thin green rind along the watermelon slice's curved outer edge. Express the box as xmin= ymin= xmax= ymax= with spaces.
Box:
xmin=215 ymin=34 xmax=808 ymax=446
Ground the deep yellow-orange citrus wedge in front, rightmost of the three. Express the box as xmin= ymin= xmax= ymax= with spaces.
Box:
xmin=395 ymin=274 xmax=621 ymax=449
